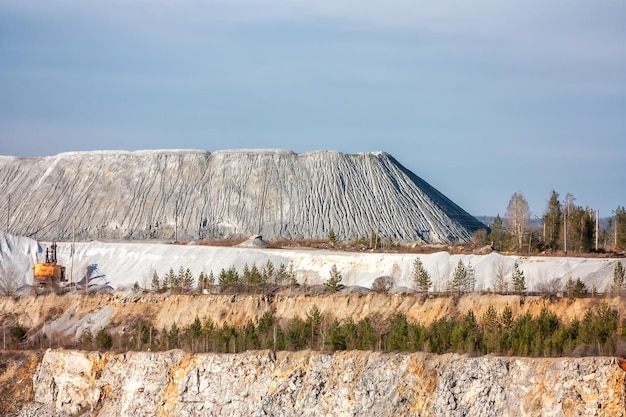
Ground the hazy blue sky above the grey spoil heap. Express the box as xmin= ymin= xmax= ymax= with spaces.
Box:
xmin=0 ymin=0 xmax=626 ymax=216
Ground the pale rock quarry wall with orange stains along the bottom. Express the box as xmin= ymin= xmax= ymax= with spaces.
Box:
xmin=8 ymin=350 xmax=626 ymax=417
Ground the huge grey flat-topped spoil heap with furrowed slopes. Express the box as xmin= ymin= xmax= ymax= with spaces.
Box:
xmin=0 ymin=150 xmax=485 ymax=243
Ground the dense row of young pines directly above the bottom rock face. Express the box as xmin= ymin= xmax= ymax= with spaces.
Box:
xmin=10 ymin=303 xmax=626 ymax=357
